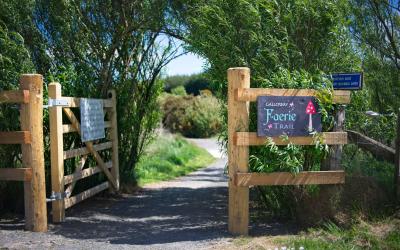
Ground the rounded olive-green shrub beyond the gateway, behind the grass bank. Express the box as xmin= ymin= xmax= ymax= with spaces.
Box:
xmin=161 ymin=95 xmax=222 ymax=138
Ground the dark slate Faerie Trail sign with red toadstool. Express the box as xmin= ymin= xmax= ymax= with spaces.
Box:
xmin=257 ymin=96 xmax=322 ymax=136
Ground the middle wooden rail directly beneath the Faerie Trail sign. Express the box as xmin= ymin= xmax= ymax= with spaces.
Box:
xmin=233 ymin=132 xmax=347 ymax=146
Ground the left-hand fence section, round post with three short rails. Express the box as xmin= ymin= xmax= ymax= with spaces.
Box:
xmin=0 ymin=74 xmax=47 ymax=232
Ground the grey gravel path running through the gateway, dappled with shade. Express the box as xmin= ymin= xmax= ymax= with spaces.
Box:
xmin=0 ymin=139 xmax=296 ymax=249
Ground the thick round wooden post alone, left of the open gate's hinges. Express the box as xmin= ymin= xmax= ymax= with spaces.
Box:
xmin=20 ymin=74 xmax=47 ymax=232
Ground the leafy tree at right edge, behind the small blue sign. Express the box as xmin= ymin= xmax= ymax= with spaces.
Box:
xmin=347 ymin=0 xmax=400 ymax=145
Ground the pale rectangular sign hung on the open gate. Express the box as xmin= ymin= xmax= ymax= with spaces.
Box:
xmin=80 ymin=98 xmax=106 ymax=142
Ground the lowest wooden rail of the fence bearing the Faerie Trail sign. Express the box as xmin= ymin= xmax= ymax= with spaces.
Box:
xmin=234 ymin=171 xmax=345 ymax=187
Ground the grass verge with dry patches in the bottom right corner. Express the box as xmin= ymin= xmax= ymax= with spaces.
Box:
xmin=218 ymin=218 xmax=400 ymax=250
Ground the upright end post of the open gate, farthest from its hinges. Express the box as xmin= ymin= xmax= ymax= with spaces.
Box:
xmin=108 ymin=90 xmax=119 ymax=191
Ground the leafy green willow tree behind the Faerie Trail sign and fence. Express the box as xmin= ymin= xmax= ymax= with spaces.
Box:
xmin=175 ymin=0 xmax=360 ymax=218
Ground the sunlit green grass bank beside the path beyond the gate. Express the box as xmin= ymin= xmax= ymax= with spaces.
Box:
xmin=135 ymin=135 xmax=214 ymax=185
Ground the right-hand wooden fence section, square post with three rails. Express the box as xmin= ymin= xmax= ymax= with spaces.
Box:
xmin=228 ymin=68 xmax=350 ymax=235
